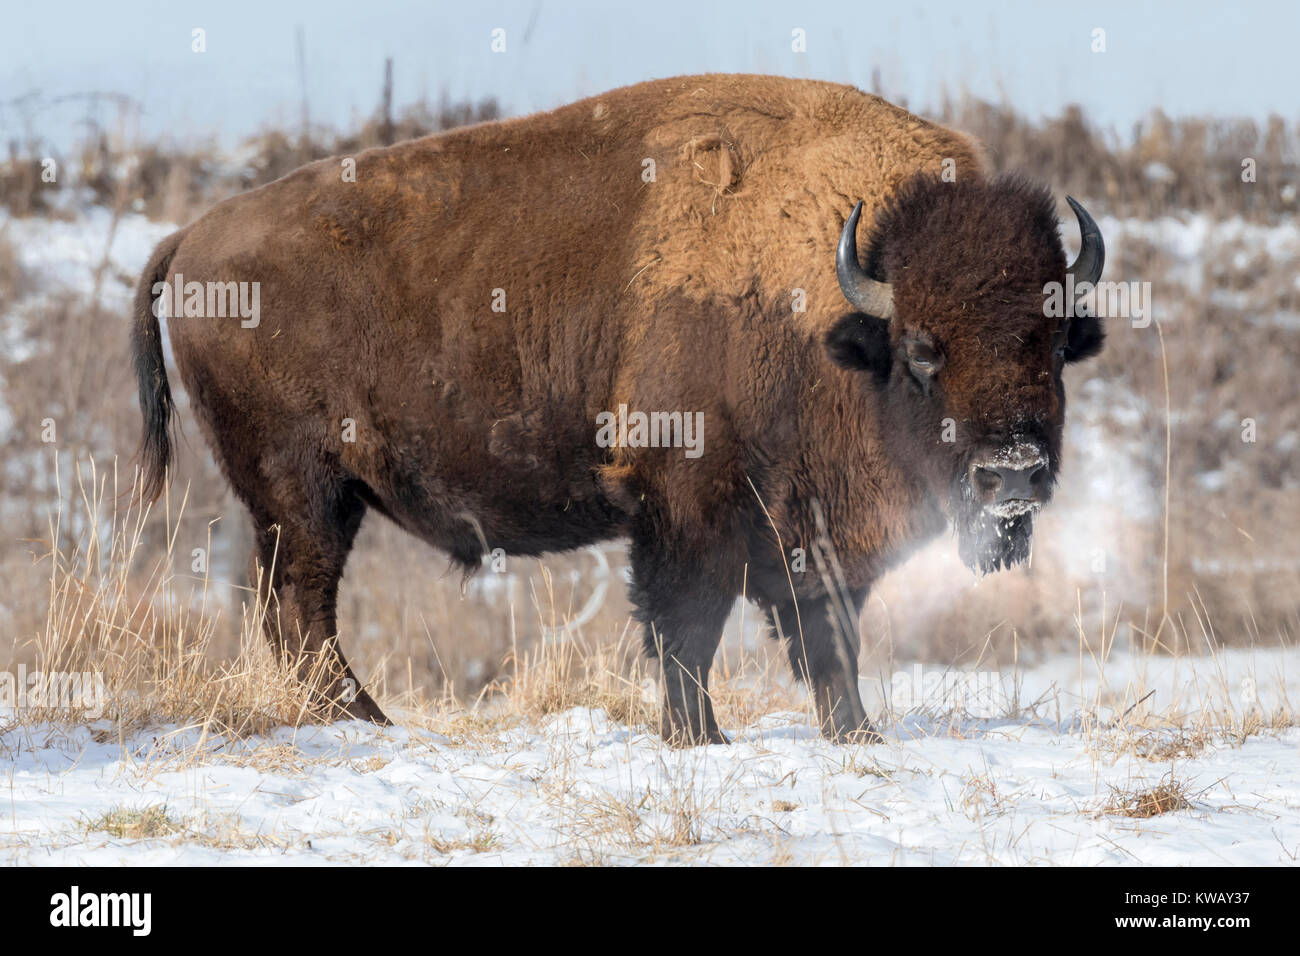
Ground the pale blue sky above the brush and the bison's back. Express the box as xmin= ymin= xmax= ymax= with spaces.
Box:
xmin=0 ymin=0 xmax=1300 ymax=146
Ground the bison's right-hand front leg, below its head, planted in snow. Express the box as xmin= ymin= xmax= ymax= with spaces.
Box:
xmin=770 ymin=591 xmax=881 ymax=744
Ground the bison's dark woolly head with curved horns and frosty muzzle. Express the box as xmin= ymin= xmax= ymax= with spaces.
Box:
xmin=827 ymin=176 xmax=1105 ymax=571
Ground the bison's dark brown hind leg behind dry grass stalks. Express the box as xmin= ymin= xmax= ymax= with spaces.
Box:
xmin=237 ymin=457 xmax=389 ymax=724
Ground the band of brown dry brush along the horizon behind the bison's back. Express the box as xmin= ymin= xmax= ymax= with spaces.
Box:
xmin=0 ymin=96 xmax=1300 ymax=224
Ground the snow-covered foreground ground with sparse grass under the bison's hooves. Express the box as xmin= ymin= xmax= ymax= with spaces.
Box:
xmin=0 ymin=650 xmax=1300 ymax=865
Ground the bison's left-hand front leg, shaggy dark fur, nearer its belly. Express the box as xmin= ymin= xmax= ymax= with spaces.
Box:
xmin=632 ymin=540 xmax=736 ymax=747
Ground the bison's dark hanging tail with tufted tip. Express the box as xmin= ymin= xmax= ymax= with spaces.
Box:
xmin=131 ymin=232 xmax=183 ymax=502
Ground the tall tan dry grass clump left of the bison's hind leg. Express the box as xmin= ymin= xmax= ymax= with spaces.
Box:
xmin=12 ymin=460 xmax=325 ymax=735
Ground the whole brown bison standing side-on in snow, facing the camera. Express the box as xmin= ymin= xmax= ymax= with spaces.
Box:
xmin=133 ymin=75 xmax=1104 ymax=744
